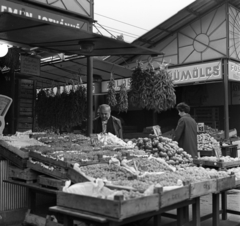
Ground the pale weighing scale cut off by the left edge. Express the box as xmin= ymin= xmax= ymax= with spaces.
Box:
xmin=0 ymin=95 xmax=12 ymax=135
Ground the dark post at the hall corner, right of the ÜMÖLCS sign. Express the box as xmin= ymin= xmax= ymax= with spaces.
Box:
xmin=223 ymin=59 xmax=229 ymax=139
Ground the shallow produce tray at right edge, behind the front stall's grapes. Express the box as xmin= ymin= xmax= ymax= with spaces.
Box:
xmin=193 ymin=159 xmax=240 ymax=168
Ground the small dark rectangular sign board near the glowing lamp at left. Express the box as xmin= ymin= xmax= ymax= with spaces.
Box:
xmin=21 ymin=55 xmax=40 ymax=76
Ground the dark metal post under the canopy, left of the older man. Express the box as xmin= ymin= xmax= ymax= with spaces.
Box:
xmin=87 ymin=57 xmax=93 ymax=136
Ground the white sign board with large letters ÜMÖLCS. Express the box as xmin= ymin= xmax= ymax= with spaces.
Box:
xmin=168 ymin=61 xmax=222 ymax=85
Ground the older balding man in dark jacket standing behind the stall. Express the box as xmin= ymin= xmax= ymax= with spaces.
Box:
xmin=93 ymin=104 xmax=123 ymax=139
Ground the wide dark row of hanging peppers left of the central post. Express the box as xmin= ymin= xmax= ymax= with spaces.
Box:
xmin=36 ymin=81 xmax=87 ymax=130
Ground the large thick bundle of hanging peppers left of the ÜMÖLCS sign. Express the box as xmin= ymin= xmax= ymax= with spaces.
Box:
xmin=131 ymin=62 xmax=176 ymax=112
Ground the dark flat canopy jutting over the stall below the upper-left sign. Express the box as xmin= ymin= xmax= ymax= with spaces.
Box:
xmin=0 ymin=13 xmax=164 ymax=56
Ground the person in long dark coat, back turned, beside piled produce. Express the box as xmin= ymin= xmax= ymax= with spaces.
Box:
xmin=173 ymin=103 xmax=197 ymax=158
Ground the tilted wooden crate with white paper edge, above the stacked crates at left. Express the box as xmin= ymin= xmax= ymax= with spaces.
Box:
xmin=27 ymin=160 xmax=67 ymax=179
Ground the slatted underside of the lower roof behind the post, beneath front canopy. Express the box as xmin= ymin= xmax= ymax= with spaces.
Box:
xmin=20 ymin=57 xmax=132 ymax=88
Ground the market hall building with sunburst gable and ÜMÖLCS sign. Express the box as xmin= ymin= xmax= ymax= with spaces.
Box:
xmin=107 ymin=1 xmax=240 ymax=139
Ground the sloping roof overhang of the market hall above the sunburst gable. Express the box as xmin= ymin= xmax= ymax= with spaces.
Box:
xmin=106 ymin=0 xmax=240 ymax=64
